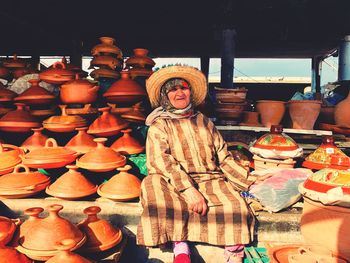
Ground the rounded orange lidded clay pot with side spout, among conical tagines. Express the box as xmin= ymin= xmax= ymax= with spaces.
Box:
xmin=60 ymin=74 xmax=99 ymax=104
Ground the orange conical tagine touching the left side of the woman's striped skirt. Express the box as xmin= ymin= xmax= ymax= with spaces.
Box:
xmin=97 ymin=165 xmax=141 ymax=201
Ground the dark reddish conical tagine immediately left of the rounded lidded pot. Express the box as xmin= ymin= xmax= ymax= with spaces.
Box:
xmin=14 ymin=79 xmax=56 ymax=105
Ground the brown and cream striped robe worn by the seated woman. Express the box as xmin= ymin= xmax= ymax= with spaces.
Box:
xmin=137 ymin=113 xmax=254 ymax=246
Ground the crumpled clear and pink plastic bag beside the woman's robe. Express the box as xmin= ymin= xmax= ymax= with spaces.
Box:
xmin=249 ymin=168 xmax=312 ymax=212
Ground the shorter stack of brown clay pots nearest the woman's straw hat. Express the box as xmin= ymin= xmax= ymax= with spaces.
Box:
xmin=125 ymin=48 xmax=156 ymax=79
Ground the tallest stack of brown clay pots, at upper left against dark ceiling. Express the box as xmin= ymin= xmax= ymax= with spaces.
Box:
xmin=89 ymin=37 xmax=123 ymax=80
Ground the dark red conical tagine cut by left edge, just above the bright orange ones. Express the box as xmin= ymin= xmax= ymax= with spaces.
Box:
xmin=0 ymin=103 xmax=41 ymax=132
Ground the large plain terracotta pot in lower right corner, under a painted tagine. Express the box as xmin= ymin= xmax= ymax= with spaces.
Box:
xmin=300 ymin=198 xmax=350 ymax=261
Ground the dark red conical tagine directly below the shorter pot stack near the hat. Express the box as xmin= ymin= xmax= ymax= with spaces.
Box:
xmin=103 ymin=71 xmax=147 ymax=104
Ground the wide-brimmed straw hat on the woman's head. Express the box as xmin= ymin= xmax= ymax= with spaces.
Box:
xmin=146 ymin=66 xmax=207 ymax=108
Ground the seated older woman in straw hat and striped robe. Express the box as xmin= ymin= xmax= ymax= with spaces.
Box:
xmin=137 ymin=66 xmax=262 ymax=263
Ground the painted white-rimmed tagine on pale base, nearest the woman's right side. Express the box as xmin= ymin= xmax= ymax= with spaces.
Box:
xmin=249 ymin=125 xmax=303 ymax=171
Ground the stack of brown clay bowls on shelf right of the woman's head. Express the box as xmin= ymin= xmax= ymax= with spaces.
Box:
xmin=215 ymin=87 xmax=248 ymax=125
